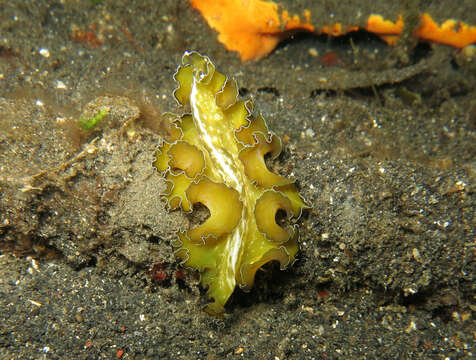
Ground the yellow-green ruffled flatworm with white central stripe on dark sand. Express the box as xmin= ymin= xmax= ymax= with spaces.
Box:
xmin=154 ymin=52 xmax=307 ymax=314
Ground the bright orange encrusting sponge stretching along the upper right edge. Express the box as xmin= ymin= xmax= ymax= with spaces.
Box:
xmin=190 ymin=0 xmax=476 ymax=61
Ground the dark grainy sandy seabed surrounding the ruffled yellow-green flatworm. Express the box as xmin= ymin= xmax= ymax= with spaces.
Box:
xmin=0 ymin=0 xmax=476 ymax=360
